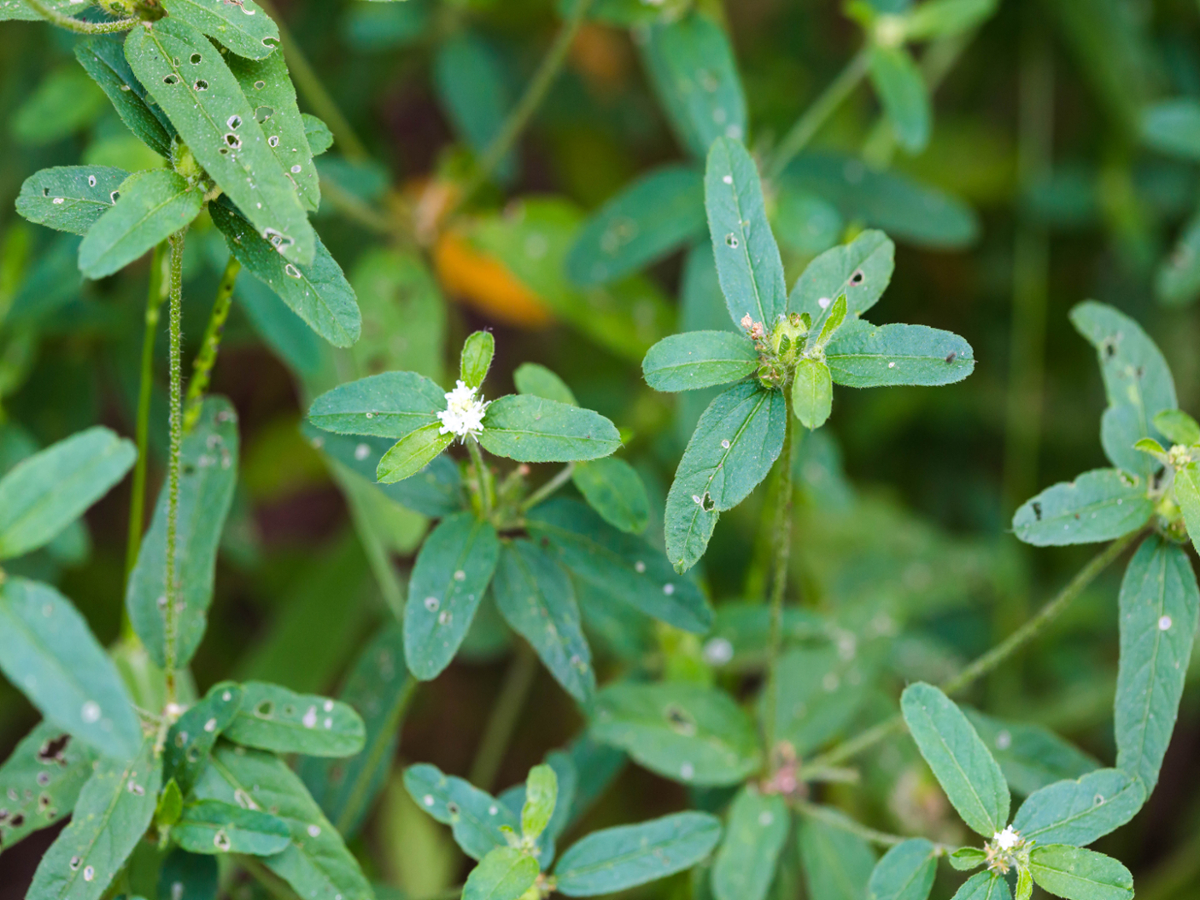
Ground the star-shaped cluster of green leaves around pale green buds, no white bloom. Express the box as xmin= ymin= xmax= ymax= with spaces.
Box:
xmin=642 ymin=138 xmax=974 ymax=572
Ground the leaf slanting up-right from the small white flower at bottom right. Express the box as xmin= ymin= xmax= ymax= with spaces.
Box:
xmin=1013 ymin=769 xmax=1146 ymax=847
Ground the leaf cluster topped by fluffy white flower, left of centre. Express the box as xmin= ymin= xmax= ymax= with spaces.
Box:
xmin=307 ymin=332 xmax=712 ymax=702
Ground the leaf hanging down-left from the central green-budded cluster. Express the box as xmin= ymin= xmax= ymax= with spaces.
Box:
xmin=666 ymin=382 xmax=787 ymax=572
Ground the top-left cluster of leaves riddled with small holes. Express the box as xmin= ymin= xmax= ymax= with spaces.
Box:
xmin=9 ymin=0 xmax=361 ymax=347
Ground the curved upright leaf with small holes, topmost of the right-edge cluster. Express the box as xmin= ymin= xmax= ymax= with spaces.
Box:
xmin=1070 ymin=301 xmax=1178 ymax=482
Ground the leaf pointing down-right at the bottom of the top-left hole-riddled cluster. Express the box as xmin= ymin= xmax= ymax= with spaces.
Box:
xmin=209 ymin=203 xmax=362 ymax=347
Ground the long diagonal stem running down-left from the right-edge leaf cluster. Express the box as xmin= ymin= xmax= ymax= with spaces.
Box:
xmin=804 ymin=532 xmax=1141 ymax=776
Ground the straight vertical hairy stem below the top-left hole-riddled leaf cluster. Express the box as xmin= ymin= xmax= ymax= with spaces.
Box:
xmin=163 ymin=229 xmax=186 ymax=701
